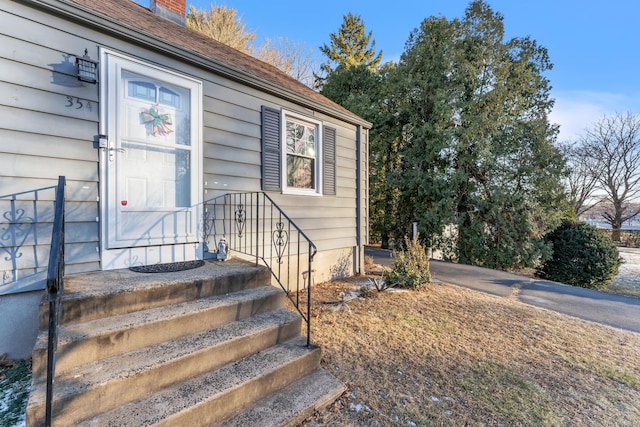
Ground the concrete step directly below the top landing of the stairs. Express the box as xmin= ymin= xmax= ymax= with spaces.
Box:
xmin=33 ymin=285 xmax=285 ymax=376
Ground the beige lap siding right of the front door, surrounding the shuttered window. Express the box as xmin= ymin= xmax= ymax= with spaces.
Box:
xmin=204 ymin=85 xmax=356 ymax=250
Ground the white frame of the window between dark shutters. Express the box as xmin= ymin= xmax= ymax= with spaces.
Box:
xmin=280 ymin=109 xmax=324 ymax=196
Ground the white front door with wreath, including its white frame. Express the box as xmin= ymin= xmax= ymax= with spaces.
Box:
xmin=101 ymin=52 xmax=202 ymax=269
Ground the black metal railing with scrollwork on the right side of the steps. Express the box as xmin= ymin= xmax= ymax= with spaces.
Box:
xmin=204 ymin=192 xmax=317 ymax=346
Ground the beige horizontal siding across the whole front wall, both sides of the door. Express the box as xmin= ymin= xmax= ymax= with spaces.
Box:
xmin=0 ymin=2 xmax=366 ymax=293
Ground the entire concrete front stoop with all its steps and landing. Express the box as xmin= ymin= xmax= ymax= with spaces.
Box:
xmin=27 ymin=261 xmax=345 ymax=427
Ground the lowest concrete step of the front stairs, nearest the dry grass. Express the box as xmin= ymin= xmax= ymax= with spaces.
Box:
xmin=216 ymin=368 xmax=346 ymax=427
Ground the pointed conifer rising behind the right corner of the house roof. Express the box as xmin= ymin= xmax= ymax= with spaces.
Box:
xmin=316 ymin=13 xmax=401 ymax=247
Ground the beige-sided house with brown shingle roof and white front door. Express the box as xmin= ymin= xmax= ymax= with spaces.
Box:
xmin=0 ymin=0 xmax=370 ymax=357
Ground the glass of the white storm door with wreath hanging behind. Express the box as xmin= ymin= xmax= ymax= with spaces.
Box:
xmin=118 ymin=70 xmax=192 ymax=209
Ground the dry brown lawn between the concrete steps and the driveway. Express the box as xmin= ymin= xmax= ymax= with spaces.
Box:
xmin=304 ymin=278 xmax=640 ymax=426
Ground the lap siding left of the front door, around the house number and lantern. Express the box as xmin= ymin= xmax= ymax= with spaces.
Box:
xmin=0 ymin=2 xmax=99 ymax=294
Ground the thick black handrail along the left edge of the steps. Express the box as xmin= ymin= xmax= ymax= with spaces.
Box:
xmin=45 ymin=176 xmax=65 ymax=427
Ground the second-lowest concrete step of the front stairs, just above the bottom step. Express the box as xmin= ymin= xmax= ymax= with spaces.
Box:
xmin=75 ymin=337 xmax=320 ymax=427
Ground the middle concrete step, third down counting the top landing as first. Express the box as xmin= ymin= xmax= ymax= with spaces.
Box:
xmin=27 ymin=309 xmax=308 ymax=426
